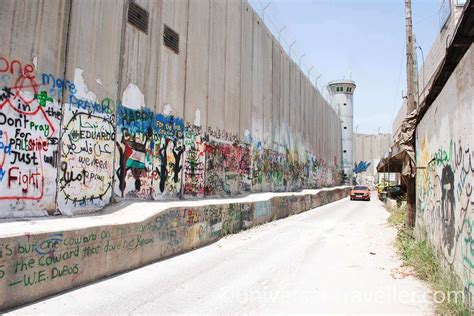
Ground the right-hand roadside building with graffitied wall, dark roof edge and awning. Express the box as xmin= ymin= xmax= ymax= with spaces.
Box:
xmin=378 ymin=0 xmax=474 ymax=308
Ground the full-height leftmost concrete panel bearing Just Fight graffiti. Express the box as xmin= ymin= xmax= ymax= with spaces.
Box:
xmin=0 ymin=1 xmax=70 ymax=217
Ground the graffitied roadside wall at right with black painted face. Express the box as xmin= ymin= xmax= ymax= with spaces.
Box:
xmin=416 ymin=44 xmax=474 ymax=307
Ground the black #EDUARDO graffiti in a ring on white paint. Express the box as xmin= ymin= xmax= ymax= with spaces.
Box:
xmin=58 ymin=109 xmax=115 ymax=213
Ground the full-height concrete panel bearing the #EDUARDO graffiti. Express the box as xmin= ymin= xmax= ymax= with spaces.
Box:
xmin=60 ymin=0 xmax=124 ymax=215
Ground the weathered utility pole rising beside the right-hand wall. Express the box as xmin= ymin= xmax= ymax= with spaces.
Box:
xmin=402 ymin=0 xmax=417 ymax=227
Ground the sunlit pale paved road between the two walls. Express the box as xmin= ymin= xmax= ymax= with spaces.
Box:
xmin=12 ymin=197 xmax=432 ymax=314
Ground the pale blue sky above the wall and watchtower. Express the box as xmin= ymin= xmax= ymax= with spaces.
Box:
xmin=249 ymin=0 xmax=439 ymax=133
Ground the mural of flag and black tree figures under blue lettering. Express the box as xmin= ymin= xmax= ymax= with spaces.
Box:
xmin=116 ymin=105 xmax=185 ymax=199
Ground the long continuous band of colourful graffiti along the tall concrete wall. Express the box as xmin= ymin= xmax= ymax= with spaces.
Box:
xmin=0 ymin=57 xmax=340 ymax=216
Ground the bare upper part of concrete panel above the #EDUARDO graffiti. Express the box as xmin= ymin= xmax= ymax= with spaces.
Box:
xmin=66 ymin=0 xmax=124 ymax=102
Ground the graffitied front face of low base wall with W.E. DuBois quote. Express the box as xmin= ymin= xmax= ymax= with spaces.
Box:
xmin=0 ymin=189 xmax=348 ymax=308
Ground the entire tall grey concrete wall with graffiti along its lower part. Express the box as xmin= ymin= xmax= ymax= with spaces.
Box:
xmin=0 ymin=0 xmax=340 ymax=217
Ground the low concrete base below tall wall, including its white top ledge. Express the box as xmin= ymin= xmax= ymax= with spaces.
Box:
xmin=0 ymin=187 xmax=350 ymax=311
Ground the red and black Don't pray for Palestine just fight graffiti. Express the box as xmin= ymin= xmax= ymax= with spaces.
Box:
xmin=0 ymin=57 xmax=61 ymax=213
